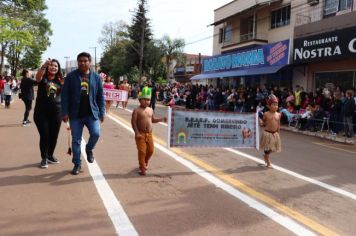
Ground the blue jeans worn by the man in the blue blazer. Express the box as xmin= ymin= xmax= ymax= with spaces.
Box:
xmin=69 ymin=115 xmax=100 ymax=165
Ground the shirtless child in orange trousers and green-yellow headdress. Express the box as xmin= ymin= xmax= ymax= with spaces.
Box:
xmin=131 ymin=87 xmax=167 ymax=175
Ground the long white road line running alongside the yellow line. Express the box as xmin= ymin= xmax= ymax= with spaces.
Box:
xmin=108 ymin=114 xmax=316 ymax=236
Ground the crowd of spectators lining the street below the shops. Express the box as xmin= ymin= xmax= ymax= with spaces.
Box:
xmin=140 ymin=83 xmax=356 ymax=137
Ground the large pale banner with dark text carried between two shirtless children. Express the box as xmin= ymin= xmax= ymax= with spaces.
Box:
xmin=167 ymin=108 xmax=259 ymax=149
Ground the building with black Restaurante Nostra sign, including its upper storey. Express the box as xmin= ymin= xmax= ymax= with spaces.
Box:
xmin=293 ymin=0 xmax=356 ymax=91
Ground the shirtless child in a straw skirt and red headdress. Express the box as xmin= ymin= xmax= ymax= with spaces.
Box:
xmin=260 ymin=94 xmax=282 ymax=168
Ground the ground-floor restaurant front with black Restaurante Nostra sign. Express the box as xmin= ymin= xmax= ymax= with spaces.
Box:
xmin=293 ymin=27 xmax=356 ymax=91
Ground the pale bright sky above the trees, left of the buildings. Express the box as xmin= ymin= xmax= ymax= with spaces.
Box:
xmin=42 ymin=0 xmax=232 ymax=67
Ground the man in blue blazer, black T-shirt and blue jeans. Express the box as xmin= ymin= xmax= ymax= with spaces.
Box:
xmin=61 ymin=52 xmax=105 ymax=175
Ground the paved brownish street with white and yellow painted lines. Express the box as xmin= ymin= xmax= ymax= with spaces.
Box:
xmin=0 ymin=99 xmax=356 ymax=236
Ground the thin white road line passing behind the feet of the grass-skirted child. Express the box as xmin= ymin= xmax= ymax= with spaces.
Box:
xmin=224 ymin=148 xmax=356 ymax=200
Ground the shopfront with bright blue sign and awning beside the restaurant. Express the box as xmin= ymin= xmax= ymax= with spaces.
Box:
xmin=191 ymin=40 xmax=292 ymax=88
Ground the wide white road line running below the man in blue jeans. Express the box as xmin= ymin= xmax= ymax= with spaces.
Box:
xmin=81 ymin=139 xmax=138 ymax=236
